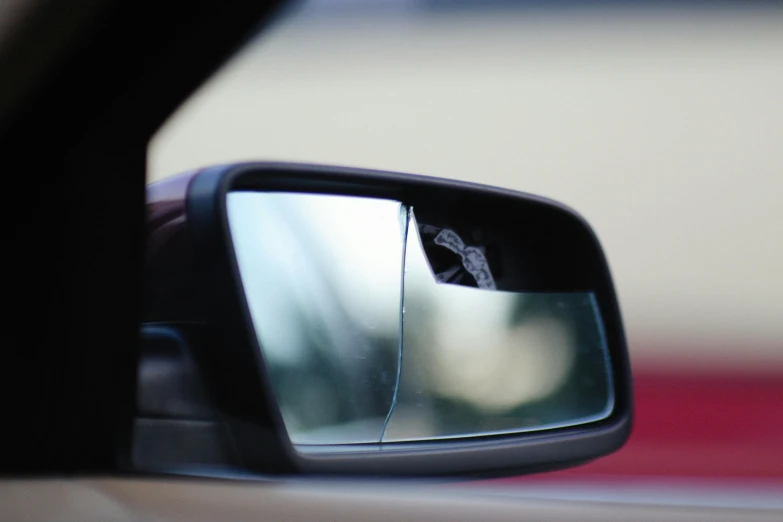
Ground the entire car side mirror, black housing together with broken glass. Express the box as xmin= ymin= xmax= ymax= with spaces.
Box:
xmin=137 ymin=163 xmax=631 ymax=476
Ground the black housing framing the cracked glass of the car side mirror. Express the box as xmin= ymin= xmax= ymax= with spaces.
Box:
xmin=137 ymin=163 xmax=632 ymax=477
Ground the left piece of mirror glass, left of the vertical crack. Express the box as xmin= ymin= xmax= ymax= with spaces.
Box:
xmin=228 ymin=192 xmax=404 ymax=443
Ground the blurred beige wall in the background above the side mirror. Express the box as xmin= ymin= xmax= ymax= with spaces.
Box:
xmin=150 ymin=8 xmax=783 ymax=368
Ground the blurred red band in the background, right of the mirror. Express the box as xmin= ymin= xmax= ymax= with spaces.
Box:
xmin=492 ymin=370 xmax=783 ymax=482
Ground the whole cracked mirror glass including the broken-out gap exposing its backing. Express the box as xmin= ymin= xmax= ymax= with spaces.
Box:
xmin=227 ymin=192 xmax=614 ymax=445
